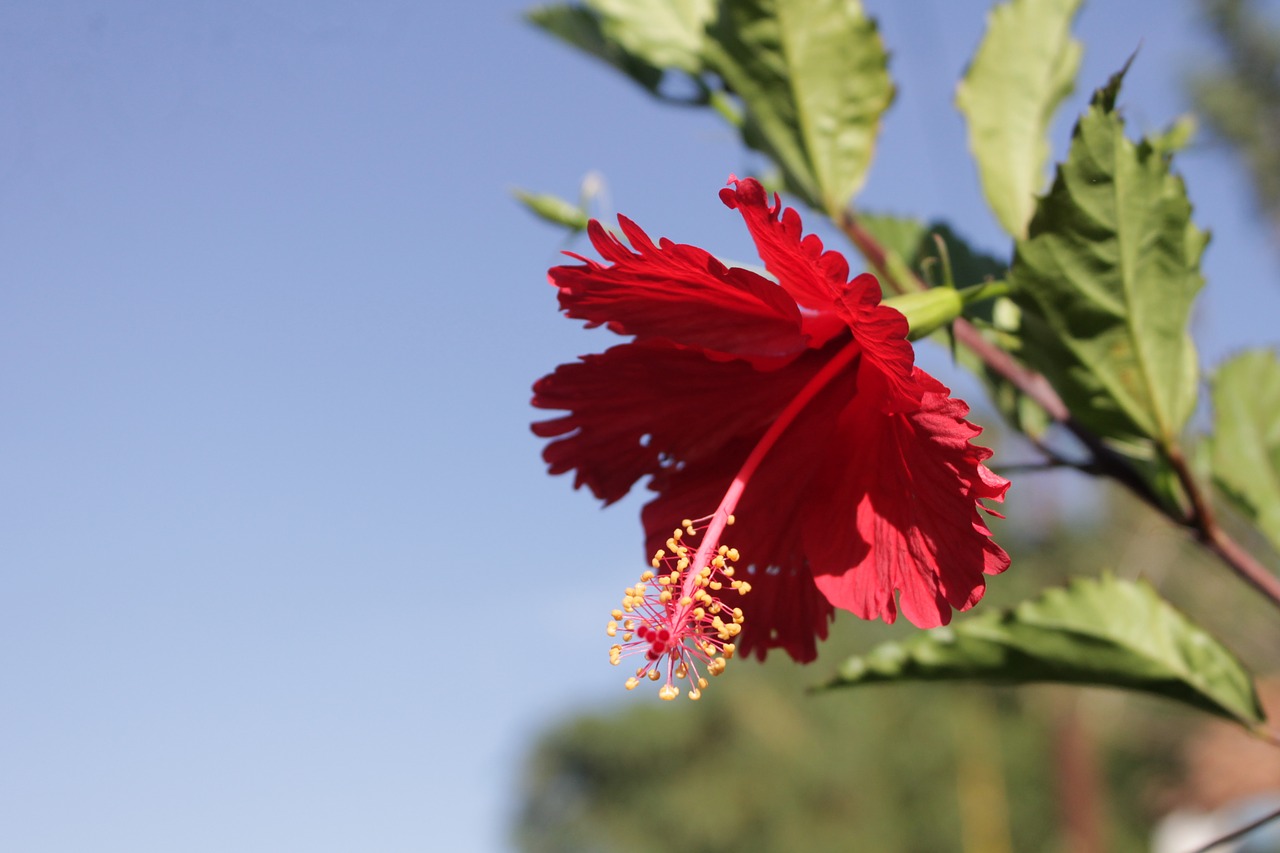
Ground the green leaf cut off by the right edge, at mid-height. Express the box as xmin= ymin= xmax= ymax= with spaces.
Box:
xmin=1211 ymin=350 xmax=1280 ymax=551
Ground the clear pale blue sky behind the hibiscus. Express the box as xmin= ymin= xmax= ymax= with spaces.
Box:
xmin=0 ymin=0 xmax=1280 ymax=853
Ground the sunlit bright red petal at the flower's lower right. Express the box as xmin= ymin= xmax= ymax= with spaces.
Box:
xmin=804 ymin=369 xmax=1009 ymax=628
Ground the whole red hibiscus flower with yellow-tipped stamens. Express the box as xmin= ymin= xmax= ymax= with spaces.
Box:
xmin=532 ymin=179 xmax=1009 ymax=698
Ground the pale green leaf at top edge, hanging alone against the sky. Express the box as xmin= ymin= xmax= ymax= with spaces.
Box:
xmin=956 ymin=0 xmax=1083 ymax=237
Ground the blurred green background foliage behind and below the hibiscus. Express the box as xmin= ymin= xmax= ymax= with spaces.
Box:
xmin=513 ymin=0 xmax=1280 ymax=853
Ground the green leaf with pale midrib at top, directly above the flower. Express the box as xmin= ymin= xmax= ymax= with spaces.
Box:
xmin=707 ymin=0 xmax=893 ymax=215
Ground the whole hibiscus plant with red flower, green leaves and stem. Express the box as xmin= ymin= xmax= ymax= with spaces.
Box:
xmin=522 ymin=0 xmax=1280 ymax=794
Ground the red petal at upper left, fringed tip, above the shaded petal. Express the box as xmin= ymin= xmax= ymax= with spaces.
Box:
xmin=548 ymin=216 xmax=809 ymax=364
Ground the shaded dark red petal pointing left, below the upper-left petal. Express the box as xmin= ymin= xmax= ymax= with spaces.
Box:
xmin=532 ymin=341 xmax=820 ymax=504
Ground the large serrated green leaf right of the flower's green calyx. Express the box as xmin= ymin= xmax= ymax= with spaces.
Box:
xmin=1010 ymin=72 xmax=1207 ymax=453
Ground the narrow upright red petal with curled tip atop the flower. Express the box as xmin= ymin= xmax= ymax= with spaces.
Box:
xmin=721 ymin=178 xmax=849 ymax=345
